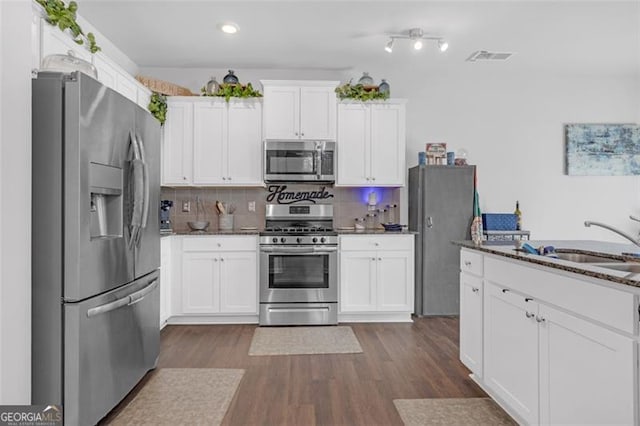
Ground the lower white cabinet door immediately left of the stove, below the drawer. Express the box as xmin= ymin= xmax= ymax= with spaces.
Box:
xmin=220 ymin=251 xmax=258 ymax=314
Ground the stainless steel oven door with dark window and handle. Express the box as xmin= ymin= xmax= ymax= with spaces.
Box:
xmin=260 ymin=246 xmax=338 ymax=303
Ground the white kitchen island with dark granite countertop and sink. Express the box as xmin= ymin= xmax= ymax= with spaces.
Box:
xmin=456 ymin=241 xmax=640 ymax=424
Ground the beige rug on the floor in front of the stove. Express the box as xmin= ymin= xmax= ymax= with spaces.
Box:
xmin=249 ymin=326 xmax=362 ymax=355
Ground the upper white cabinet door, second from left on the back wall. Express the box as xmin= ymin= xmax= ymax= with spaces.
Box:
xmin=193 ymin=101 xmax=227 ymax=185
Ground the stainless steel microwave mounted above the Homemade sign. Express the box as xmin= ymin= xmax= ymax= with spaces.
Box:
xmin=264 ymin=140 xmax=336 ymax=183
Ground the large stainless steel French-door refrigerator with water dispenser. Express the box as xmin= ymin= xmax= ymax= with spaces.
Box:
xmin=32 ymin=72 xmax=160 ymax=425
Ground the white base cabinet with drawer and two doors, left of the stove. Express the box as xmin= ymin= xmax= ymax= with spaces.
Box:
xmin=176 ymin=236 xmax=258 ymax=322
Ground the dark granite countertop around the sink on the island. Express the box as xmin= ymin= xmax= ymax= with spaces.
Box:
xmin=453 ymin=240 xmax=640 ymax=288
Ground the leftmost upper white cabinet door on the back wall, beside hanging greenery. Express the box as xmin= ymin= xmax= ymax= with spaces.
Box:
xmin=162 ymin=101 xmax=193 ymax=185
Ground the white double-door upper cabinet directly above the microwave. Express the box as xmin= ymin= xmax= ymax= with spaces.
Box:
xmin=261 ymin=80 xmax=339 ymax=140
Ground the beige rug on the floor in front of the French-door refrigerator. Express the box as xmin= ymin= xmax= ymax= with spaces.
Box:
xmin=110 ymin=368 xmax=244 ymax=425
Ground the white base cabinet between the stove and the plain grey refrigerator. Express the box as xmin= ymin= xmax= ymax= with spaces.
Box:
xmin=339 ymin=235 xmax=414 ymax=321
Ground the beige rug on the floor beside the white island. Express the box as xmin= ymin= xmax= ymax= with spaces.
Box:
xmin=393 ymin=398 xmax=517 ymax=426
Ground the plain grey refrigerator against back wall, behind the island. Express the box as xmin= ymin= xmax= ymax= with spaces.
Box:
xmin=409 ymin=166 xmax=475 ymax=316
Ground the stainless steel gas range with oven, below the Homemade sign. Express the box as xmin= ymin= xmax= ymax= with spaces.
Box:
xmin=260 ymin=204 xmax=338 ymax=325
